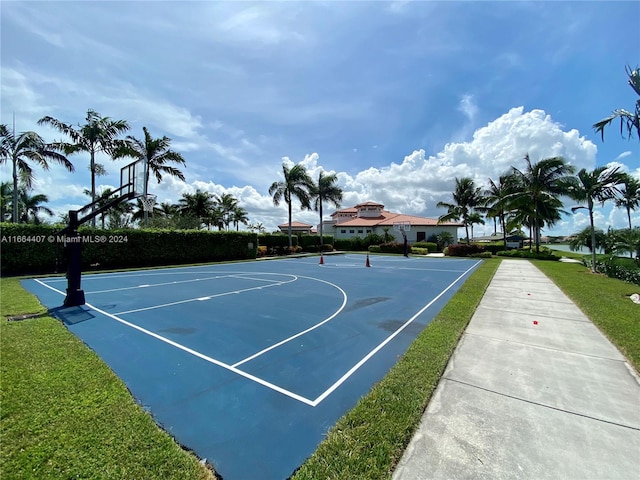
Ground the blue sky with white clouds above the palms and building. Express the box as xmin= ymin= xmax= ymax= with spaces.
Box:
xmin=0 ymin=1 xmax=640 ymax=235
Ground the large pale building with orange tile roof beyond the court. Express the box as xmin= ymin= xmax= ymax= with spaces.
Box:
xmin=318 ymin=202 xmax=464 ymax=243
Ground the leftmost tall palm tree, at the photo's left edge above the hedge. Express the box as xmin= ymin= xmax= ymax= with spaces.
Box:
xmin=0 ymin=124 xmax=74 ymax=222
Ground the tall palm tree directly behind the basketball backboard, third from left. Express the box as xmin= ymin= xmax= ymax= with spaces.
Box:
xmin=114 ymin=127 xmax=186 ymax=225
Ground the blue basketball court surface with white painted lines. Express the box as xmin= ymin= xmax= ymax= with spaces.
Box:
xmin=23 ymin=254 xmax=479 ymax=480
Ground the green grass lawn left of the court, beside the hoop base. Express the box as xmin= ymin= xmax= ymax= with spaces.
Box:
xmin=0 ymin=278 xmax=214 ymax=480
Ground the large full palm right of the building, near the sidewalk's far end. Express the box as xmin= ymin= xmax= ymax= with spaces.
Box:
xmin=507 ymin=154 xmax=574 ymax=252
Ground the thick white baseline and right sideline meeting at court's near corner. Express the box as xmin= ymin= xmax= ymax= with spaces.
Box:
xmin=33 ymin=260 xmax=481 ymax=407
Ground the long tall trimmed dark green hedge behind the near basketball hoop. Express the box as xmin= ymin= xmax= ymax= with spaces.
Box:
xmin=0 ymin=223 xmax=258 ymax=275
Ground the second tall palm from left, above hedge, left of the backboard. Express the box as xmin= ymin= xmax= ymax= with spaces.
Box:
xmin=38 ymin=110 xmax=129 ymax=227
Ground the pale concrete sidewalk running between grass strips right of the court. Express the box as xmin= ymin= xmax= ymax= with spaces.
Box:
xmin=393 ymin=260 xmax=640 ymax=480
